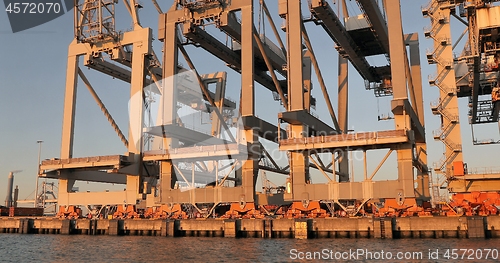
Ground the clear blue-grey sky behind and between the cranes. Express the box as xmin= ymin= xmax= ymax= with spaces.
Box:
xmin=0 ymin=0 xmax=500 ymax=204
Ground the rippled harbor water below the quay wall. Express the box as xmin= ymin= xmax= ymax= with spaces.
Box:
xmin=0 ymin=234 xmax=500 ymax=262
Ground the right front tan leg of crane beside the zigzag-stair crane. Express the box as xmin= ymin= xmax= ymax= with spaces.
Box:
xmin=385 ymin=0 xmax=415 ymax=197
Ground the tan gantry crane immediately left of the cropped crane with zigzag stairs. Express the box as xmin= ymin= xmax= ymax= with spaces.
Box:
xmin=279 ymin=0 xmax=429 ymax=218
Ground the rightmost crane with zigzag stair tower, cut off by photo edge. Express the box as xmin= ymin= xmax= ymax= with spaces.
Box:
xmin=422 ymin=0 xmax=500 ymax=215
